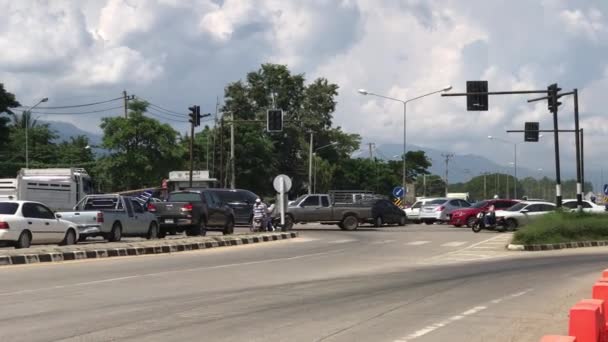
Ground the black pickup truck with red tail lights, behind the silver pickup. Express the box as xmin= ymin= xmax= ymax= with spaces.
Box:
xmin=148 ymin=190 xmax=234 ymax=237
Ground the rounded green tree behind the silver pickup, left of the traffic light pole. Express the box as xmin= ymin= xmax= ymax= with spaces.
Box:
xmin=95 ymin=100 xmax=185 ymax=191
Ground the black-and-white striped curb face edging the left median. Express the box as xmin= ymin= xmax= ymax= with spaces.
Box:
xmin=0 ymin=232 xmax=299 ymax=266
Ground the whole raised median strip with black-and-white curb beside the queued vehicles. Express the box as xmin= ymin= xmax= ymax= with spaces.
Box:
xmin=0 ymin=232 xmax=298 ymax=266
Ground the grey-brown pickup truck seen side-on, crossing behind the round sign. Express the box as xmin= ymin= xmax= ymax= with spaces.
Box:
xmin=282 ymin=194 xmax=374 ymax=230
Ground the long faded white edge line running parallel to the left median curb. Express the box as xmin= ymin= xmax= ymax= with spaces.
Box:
xmin=0 ymin=249 xmax=345 ymax=296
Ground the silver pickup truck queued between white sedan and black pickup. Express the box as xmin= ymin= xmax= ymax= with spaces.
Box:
xmin=57 ymin=195 xmax=158 ymax=241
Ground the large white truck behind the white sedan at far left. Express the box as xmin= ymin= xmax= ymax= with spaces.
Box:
xmin=0 ymin=168 xmax=93 ymax=210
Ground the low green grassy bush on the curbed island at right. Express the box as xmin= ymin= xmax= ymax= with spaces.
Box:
xmin=513 ymin=212 xmax=608 ymax=245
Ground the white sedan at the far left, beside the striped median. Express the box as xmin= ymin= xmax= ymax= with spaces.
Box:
xmin=0 ymin=201 xmax=78 ymax=248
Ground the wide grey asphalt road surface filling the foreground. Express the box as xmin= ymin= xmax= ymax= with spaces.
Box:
xmin=0 ymin=225 xmax=608 ymax=341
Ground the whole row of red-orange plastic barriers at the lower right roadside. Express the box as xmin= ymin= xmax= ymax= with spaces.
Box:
xmin=540 ymin=269 xmax=608 ymax=342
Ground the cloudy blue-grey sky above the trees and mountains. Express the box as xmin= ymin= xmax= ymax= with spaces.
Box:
xmin=0 ymin=0 xmax=608 ymax=187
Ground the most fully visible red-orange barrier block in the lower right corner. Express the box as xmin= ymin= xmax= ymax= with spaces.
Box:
xmin=568 ymin=299 xmax=606 ymax=342
